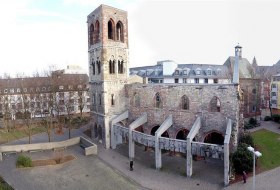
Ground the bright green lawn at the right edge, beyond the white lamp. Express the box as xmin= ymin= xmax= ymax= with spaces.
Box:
xmin=252 ymin=129 xmax=280 ymax=170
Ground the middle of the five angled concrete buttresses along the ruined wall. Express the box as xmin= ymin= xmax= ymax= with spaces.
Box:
xmin=155 ymin=115 xmax=173 ymax=169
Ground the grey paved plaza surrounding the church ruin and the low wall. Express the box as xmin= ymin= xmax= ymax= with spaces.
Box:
xmin=0 ymin=122 xmax=280 ymax=190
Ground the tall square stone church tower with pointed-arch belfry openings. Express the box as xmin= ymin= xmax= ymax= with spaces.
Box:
xmin=87 ymin=5 xmax=129 ymax=148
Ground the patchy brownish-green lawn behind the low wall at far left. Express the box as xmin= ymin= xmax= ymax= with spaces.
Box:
xmin=0 ymin=127 xmax=46 ymax=144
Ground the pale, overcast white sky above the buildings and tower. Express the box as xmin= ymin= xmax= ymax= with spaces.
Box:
xmin=0 ymin=0 xmax=280 ymax=74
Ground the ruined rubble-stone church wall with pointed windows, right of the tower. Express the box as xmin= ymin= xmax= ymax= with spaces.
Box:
xmin=126 ymin=84 xmax=239 ymax=141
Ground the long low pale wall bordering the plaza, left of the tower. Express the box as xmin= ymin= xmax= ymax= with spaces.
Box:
xmin=0 ymin=137 xmax=97 ymax=161
